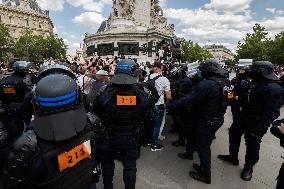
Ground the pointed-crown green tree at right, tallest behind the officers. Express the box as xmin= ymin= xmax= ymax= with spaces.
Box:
xmin=237 ymin=24 xmax=272 ymax=60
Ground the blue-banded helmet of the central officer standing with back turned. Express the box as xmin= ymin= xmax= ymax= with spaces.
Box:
xmin=111 ymin=59 xmax=139 ymax=85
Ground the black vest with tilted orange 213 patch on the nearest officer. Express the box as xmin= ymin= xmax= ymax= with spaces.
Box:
xmin=36 ymin=123 xmax=96 ymax=189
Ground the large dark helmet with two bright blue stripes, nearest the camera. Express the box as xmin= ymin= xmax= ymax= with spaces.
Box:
xmin=33 ymin=71 xmax=87 ymax=141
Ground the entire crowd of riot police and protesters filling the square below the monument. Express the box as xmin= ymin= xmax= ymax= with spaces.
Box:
xmin=0 ymin=57 xmax=284 ymax=189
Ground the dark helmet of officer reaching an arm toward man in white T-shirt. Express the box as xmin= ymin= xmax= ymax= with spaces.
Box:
xmin=198 ymin=59 xmax=229 ymax=76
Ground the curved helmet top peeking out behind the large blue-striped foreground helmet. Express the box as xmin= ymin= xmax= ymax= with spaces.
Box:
xmin=37 ymin=64 xmax=76 ymax=81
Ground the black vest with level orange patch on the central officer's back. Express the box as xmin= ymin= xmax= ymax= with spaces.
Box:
xmin=104 ymin=85 xmax=144 ymax=135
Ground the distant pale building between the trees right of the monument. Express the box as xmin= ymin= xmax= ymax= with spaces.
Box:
xmin=204 ymin=44 xmax=234 ymax=63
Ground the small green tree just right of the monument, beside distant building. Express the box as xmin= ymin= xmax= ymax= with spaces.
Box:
xmin=181 ymin=41 xmax=213 ymax=62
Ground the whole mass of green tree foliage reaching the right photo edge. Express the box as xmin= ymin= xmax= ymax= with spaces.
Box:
xmin=237 ymin=24 xmax=284 ymax=64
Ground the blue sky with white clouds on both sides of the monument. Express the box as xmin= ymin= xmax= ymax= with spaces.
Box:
xmin=27 ymin=0 xmax=284 ymax=54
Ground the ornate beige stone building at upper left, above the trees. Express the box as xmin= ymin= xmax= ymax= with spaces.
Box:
xmin=0 ymin=0 xmax=54 ymax=39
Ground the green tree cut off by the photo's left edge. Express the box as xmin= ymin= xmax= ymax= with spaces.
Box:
xmin=0 ymin=24 xmax=14 ymax=59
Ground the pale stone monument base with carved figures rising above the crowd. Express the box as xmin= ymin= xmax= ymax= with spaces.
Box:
xmin=84 ymin=0 xmax=174 ymax=61
